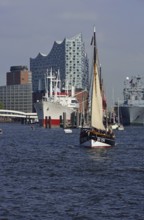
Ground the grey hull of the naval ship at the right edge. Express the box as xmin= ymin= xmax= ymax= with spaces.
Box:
xmin=119 ymin=105 xmax=144 ymax=125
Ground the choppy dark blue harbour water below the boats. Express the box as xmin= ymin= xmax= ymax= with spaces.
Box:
xmin=0 ymin=124 xmax=144 ymax=220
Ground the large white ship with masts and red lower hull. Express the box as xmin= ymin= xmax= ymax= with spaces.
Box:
xmin=34 ymin=70 xmax=79 ymax=127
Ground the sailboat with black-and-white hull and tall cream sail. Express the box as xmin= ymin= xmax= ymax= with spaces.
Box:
xmin=80 ymin=27 xmax=115 ymax=148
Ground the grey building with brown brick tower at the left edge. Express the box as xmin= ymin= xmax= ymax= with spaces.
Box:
xmin=0 ymin=66 xmax=33 ymax=112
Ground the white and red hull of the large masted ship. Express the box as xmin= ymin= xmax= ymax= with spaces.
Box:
xmin=34 ymin=101 xmax=74 ymax=127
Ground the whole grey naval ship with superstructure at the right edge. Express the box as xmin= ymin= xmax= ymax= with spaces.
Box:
xmin=119 ymin=76 xmax=144 ymax=125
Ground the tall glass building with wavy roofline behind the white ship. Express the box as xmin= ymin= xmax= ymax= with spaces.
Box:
xmin=30 ymin=34 xmax=88 ymax=92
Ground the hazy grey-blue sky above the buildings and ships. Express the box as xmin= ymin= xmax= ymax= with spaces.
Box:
xmin=0 ymin=0 xmax=144 ymax=106
